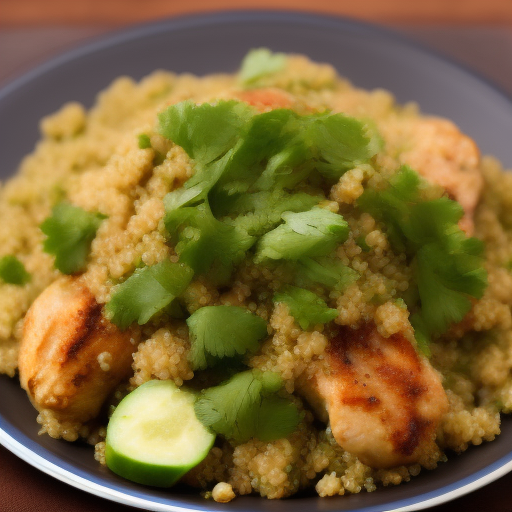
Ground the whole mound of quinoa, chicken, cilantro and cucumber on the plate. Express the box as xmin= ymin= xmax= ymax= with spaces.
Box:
xmin=0 ymin=49 xmax=512 ymax=502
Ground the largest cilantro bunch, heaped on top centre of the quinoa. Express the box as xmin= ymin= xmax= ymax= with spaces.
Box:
xmin=159 ymin=101 xmax=380 ymax=282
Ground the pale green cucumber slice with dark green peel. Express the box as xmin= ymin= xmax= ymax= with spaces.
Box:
xmin=105 ymin=380 xmax=215 ymax=487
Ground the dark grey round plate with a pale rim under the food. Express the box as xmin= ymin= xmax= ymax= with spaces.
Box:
xmin=0 ymin=11 xmax=512 ymax=512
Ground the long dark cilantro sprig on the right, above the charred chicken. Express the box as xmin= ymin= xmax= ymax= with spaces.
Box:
xmin=358 ymin=166 xmax=487 ymax=340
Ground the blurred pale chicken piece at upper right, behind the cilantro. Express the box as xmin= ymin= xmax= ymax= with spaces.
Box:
xmin=400 ymin=117 xmax=484 ymax=236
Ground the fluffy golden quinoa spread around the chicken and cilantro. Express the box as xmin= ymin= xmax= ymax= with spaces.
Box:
xmin=0 ymin=52 xmax=512 ymax=503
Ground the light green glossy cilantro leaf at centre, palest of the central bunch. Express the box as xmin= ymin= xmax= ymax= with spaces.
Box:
xmin=256 ymin=207 xmax=349 ymax=262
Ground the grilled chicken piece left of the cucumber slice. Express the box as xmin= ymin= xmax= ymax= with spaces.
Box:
xmin=19 ymin=277 xmax=135 ymax=423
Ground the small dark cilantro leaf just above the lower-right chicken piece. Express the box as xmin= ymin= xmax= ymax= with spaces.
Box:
xmin=274 ymin=286 xmax=338 ymax=330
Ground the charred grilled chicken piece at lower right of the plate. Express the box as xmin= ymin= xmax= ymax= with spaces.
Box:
xmin=300 ymin=324 xmax=448 ymax=468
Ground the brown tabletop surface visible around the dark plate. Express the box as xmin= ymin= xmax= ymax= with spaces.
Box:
xmin=0 ymin=0 xmax=512 ymax=512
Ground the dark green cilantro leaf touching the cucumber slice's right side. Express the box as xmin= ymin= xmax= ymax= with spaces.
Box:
xmin=194 ymin=370 xmax=300 ymax=443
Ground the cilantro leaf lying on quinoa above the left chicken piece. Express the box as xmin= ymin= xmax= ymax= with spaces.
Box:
xmin=41 ymin=203 xmax=106 ymax=274
